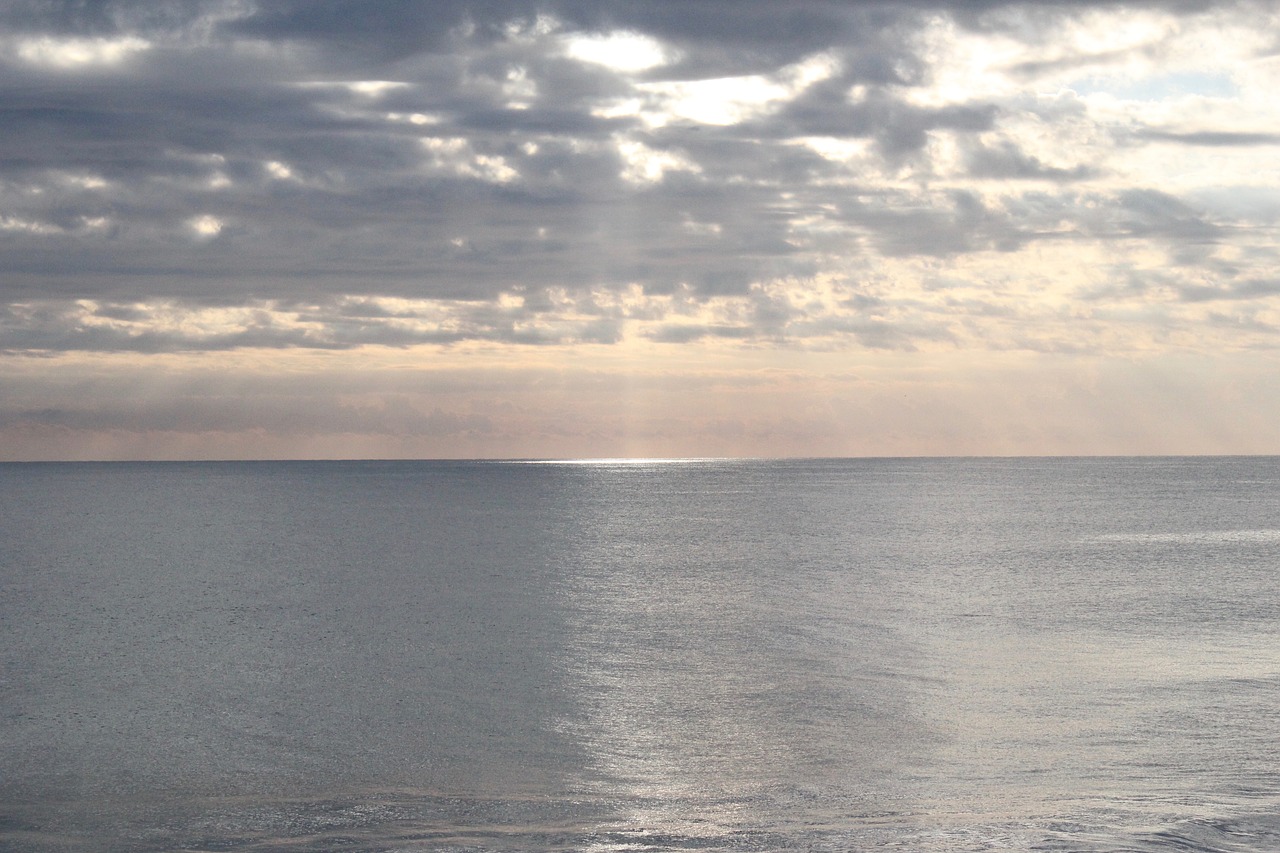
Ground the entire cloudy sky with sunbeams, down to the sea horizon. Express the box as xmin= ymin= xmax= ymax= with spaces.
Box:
xmin=0 ymin=0 xmax=1280 ymax=460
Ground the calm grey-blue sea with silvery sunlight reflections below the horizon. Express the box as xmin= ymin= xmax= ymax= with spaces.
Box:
xmin=0 ymin=459 xmax=1280 ymax=853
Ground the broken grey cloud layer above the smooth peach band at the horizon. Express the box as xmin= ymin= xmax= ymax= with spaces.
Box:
xmin=0 ymin=0 xmax=1280 ymax=455
